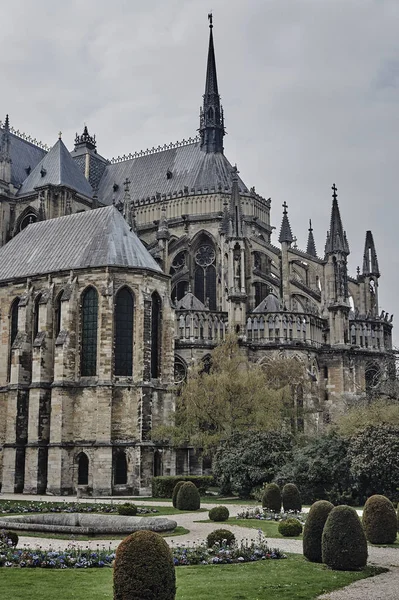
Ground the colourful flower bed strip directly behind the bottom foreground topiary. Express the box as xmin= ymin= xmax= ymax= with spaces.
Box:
xmin=0 ymin=531 xmax=286 ymax=569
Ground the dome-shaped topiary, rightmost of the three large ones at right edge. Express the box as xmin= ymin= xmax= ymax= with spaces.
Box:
xmin=363 ymin=494 xmax=398 ymax=544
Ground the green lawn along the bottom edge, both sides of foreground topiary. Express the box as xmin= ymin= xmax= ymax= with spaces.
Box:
xmin=0 ymin=555 xmax=385 ymax=600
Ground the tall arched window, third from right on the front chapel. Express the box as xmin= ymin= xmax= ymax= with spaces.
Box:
xmin=80 ymin=287 xmax=98 ymax=377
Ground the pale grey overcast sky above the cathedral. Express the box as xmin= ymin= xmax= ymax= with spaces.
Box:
xmin=0 ymin=0 xmax=399 ymax=337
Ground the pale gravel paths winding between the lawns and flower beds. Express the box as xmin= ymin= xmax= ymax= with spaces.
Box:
xmin=0 ymin=494 xmax=399 ymax=600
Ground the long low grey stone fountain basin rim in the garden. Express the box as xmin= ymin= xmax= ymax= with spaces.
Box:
xmin=0 ymin=513 xmax=177 ymax=535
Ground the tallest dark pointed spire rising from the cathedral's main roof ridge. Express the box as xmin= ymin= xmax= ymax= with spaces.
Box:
xmin=199 ymin=13 xmax=225 ymax=153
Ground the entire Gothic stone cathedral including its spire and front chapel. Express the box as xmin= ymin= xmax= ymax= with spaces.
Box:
xmin=0 ymin=19 xmax=392 ymax=495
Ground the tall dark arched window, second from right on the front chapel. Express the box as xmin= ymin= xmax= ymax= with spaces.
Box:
xmin=115 ymin=287 xmax=134 ymax=377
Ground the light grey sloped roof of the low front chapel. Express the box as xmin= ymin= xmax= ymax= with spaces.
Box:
xmin=0 ymin=206 xmax=162 ymax=281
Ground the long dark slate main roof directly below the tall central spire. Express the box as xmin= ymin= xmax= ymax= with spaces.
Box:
xmin=98 ymin=142 xmax=248 ymax=204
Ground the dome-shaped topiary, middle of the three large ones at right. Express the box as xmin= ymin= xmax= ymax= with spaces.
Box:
xmin=321 ymin=505 xmax=367 ymax=571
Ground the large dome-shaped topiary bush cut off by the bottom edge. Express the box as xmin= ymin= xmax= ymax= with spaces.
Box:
xmin=114 ymin=531 xmax=176 ymax=600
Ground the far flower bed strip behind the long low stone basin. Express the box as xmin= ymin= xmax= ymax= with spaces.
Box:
xmin=0 ymin=500 xmax=159 ymax=515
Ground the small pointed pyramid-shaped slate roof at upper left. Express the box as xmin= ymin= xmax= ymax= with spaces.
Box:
xmin=18 ymin=139 xmax=93 ymax=198
